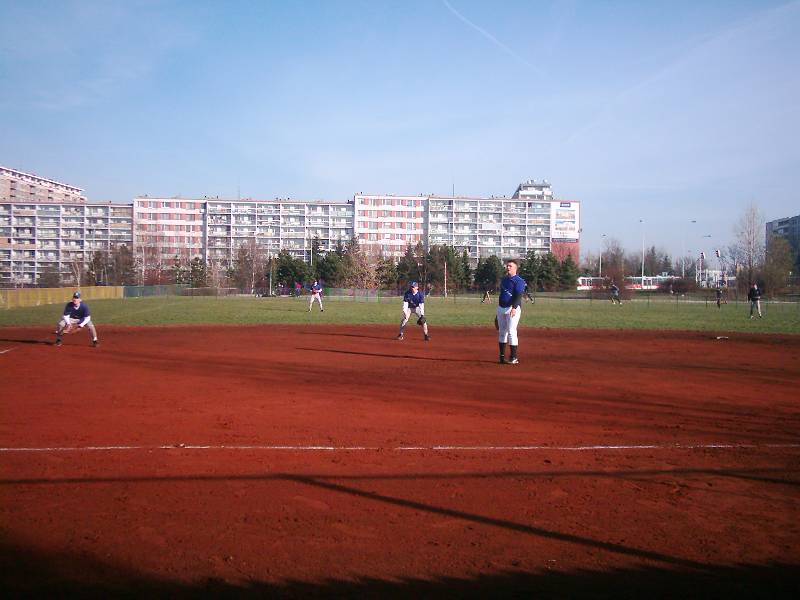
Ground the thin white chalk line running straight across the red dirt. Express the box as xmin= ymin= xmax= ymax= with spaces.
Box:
xmin=0 ymin=444 xmax=800 ymax=453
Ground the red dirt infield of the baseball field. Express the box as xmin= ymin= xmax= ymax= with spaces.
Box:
xmin=0 ymin=324 xmax=800 ymax=597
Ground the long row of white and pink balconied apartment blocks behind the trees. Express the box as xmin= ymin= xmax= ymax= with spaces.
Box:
xmin=0 ymin=167 xmax=580 ymax=286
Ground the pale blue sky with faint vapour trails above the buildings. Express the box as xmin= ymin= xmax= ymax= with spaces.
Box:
xmin=0 ymin=0 xmax=800 ymax=253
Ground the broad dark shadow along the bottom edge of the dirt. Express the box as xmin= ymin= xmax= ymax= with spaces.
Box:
xmin=0 ymin=542 xmax=800 ymax=598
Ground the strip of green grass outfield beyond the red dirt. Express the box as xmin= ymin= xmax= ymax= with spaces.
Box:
xmin=0 ymin=296 xmax=800 ymax=334
